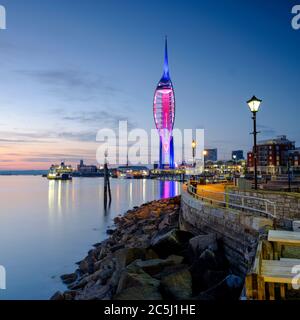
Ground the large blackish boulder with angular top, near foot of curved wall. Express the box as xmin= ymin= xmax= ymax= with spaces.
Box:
xmin=151 ymin=229 xmax=193 ymax=258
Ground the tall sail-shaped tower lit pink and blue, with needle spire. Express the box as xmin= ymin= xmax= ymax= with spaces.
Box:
xmin=153 ymin=38 xmax=175 ymax=169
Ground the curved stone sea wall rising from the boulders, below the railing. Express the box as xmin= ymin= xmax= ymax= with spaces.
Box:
xmin=180 ymin=191 xmax=273 ymax=276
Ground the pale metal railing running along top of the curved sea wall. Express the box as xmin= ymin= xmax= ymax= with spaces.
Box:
xmin=187 ymin=184 xmax=276 ymax=218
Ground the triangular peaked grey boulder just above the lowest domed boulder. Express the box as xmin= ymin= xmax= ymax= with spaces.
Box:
xmin=117 ymin=264 xmax=159 ymax=294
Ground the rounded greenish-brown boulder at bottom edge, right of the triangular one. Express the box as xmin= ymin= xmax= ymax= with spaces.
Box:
xmin=161 ymin=268 xmax=192 ymax=300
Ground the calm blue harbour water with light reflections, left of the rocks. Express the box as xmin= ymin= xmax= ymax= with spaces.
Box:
xmin=0 ymin=176 xmax=180 ymax=299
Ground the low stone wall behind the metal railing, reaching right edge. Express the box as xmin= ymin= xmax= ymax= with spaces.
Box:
xmin=227 ymin=188 xmax=300 ymax=230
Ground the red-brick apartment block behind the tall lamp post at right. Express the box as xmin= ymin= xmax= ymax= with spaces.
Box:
xmin=247 ymin=135 xmax=295 ymax=174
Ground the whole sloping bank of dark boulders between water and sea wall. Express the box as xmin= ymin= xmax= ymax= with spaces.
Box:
xmin=51 ymin=197 xmax=243 ymax=300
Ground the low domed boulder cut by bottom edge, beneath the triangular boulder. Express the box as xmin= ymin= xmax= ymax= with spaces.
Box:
xmin=113 ymin=286 xmax=162 ymax=300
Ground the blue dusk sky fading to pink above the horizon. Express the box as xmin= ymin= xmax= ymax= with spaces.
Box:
xmin=0 ymin=0 xmax=300 ymax=170
